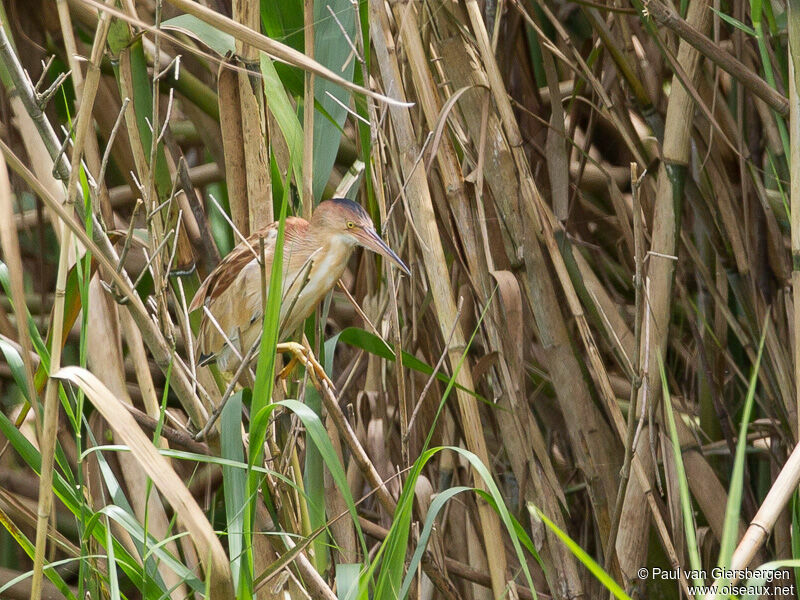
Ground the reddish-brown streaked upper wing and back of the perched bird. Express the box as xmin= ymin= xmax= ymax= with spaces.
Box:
xmin=189 ymin=217 xmax=308 ymax=312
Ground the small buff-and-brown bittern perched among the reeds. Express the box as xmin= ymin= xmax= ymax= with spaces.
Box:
xmin=189 ymin=198 xmax=410 ymax=373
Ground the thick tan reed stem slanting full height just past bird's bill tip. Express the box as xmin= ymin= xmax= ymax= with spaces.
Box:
xmin=369 ymin=0 xmax=506 ymax=598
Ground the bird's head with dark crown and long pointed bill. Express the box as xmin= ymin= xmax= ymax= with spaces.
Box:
xmin=311 ymin=198 xmax=411 ymax=275
